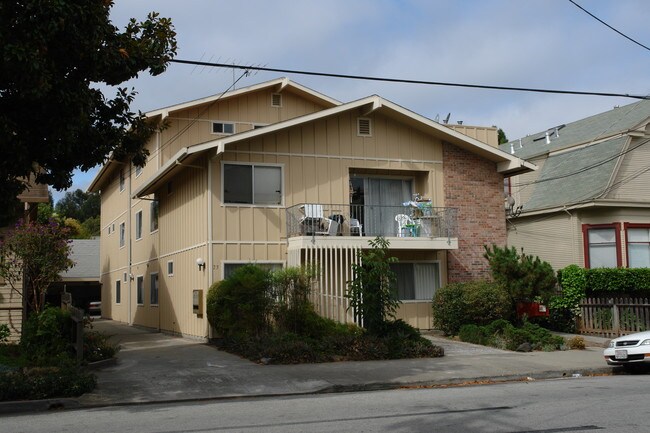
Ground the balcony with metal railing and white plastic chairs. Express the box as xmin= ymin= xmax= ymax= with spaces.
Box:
xmin=286 ymin=202 xmax=458 ymax=249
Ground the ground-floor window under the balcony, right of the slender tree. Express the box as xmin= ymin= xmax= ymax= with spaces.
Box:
xmin=390 ymin=262 xmax=440 ymax=301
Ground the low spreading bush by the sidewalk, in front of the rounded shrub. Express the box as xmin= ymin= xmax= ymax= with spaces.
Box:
xmin=458 ymin=320 xmax=564 ymax=351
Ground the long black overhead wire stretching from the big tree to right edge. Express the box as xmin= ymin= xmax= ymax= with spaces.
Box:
xmin=170 ymin=59 xmax=649 ymax=99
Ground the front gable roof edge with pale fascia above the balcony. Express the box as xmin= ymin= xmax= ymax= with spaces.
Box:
xmin=133 ymin=95 xmax=536 ymax=197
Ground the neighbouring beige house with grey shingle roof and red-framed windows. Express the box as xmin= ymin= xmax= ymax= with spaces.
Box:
xmin=501 ymin=100 xmax=650 ymax=270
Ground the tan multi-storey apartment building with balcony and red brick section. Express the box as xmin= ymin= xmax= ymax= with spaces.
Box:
xmin=90 ymin=79 xmax=534 ymax=338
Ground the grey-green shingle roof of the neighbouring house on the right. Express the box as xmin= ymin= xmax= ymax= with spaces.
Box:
xmin=500 ymin=100 xmax=650 ymax=213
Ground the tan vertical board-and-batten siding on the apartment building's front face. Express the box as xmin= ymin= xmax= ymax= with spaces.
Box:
xmin=212 ymin=112 xmax=446 ymax=329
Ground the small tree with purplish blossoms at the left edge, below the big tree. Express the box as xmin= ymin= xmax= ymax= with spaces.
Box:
xmin=0 ymin=220 xmax=74 ymax=313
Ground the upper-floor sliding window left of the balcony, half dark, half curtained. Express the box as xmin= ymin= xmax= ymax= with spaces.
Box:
xmin=223 ymin=163 xmax=282 ymax=206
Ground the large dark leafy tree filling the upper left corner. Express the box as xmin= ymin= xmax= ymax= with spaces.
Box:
xmin=0 ymin=0 xmax=176 ymax=213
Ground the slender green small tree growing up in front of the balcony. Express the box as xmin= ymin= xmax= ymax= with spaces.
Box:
xmin=345 ymin=236 xmax=400 ymax=334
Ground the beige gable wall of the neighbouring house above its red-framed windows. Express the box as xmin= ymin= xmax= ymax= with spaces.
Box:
xmin=605 ymin=138 xmax=650 ymax=201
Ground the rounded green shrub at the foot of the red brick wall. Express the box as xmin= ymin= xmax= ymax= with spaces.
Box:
xmin=432 ymin=281 xmax=512 ymax=335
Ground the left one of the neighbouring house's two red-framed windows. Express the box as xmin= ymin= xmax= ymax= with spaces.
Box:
xmin=582 ymin=223 xmax=621 ymax=268
